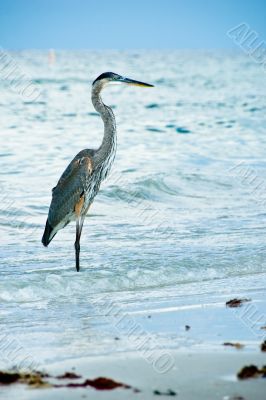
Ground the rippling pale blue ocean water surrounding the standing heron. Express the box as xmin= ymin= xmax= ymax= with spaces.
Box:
xmin=0 ymin=51 xmax=266 ymax=365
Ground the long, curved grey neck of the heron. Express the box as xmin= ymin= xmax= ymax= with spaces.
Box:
xmin=91 ymin=87 xmax=116 ymax=163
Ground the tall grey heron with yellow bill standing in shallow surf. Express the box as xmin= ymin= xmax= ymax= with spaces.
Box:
xmin=42 ymin=72 xmax=153 ymax=271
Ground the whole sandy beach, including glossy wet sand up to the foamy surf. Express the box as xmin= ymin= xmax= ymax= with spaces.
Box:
xmin=0 ymin=282 xmax=266 ymax=400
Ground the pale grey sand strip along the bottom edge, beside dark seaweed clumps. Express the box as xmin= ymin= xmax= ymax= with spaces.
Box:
xmin=0 ymin=349 xmax=266 ymax=400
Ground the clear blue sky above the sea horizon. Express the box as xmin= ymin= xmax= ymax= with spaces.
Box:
xmin=0 ymin=0 xmax=266 ymax=49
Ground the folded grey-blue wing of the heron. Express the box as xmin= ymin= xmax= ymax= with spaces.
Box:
xmin=48 ymin=151 xmax=93 ymax=227
